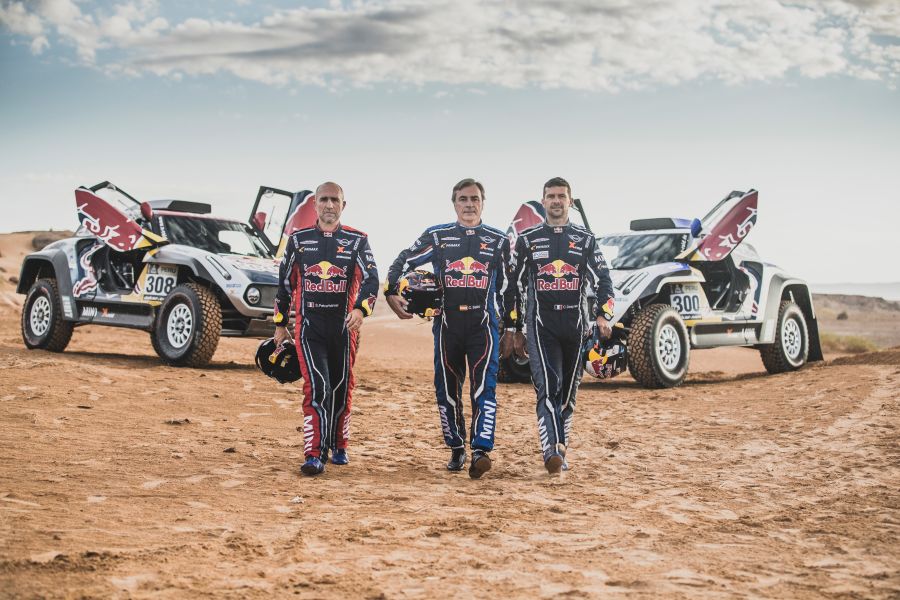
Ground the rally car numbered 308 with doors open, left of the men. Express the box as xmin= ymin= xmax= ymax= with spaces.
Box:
xmin=17 ymin=181 xmax=315 ymax=367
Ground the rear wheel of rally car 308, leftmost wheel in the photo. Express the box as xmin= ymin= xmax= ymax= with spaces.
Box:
xmin=22 ymin=279 xmax=75 ymax=352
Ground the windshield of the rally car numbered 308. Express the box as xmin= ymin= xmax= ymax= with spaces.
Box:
xmin=159 ymin=215 xmax=272 ymax=258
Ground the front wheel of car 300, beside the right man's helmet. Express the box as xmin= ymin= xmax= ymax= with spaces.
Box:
xmin=627 ymin=304 xmax=691 ymax=388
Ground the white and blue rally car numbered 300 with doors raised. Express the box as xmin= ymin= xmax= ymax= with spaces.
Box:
xmin=500 ymin=190 xmax=822 ymax=388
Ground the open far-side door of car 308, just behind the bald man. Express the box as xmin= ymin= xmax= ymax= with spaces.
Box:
xmin=250 ymin=186 xmax=316 ymax=259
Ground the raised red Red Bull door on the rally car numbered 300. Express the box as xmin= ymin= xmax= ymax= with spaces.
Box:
xmin=677 ymin=190 xmax=759 ymax=262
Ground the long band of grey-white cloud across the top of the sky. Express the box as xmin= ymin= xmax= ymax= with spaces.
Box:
xmin=0 ymin=0 xmax=900 ymax=91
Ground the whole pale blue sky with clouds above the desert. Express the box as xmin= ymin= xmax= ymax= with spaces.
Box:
xmin=0 ymin=0 xmax=900 ymax=283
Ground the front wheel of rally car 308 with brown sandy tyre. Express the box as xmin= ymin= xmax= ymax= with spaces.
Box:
xmin=150 ymin=283 xmax=222 ymax=367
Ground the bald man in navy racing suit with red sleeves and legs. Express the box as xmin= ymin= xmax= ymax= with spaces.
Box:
xmin=274 ymin=182 xmax=378 ymax=475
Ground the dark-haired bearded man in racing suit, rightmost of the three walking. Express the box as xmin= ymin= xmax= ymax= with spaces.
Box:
xmin=502 ymin=177 xmax=614 ymax=473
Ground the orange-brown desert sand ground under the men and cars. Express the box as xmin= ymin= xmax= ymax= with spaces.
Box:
xmin=0 ymin=233 xmax=900 ymax=598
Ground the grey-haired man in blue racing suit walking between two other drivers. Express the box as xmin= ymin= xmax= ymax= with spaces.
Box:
xmin=385 ymin=179 xmax=513 ymax=479
